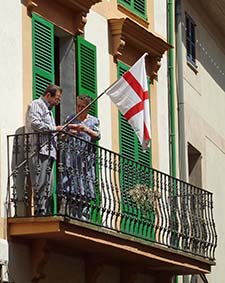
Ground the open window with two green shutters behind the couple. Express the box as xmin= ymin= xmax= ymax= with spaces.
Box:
xmin=32 ymin=13 xmax=97 ymax=120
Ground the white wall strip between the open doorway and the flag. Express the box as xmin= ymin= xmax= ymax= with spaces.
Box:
xmin=84 ymin=11 xmax=112 ymax=149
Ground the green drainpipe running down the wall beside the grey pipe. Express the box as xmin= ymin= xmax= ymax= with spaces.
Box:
xmin=168 ymin=0 xmax=177 ymax=180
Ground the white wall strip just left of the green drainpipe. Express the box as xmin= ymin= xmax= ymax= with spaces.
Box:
xmin=151 ymin=0 xmax=169 ymax=173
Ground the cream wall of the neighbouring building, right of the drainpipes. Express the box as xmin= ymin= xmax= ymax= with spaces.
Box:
xmin=183 ymin=1 xmax=225 ymax=283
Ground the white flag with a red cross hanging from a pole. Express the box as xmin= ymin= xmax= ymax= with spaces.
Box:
xmin=106 ymin=53 xmax=151 ymax=150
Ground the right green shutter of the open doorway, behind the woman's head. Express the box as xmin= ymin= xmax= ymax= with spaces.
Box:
xmin=76 ymin=36 xmax=98 ymax=116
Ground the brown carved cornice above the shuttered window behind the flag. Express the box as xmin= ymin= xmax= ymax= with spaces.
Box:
xmin=108 ymin=18 xmax=172 ymax=80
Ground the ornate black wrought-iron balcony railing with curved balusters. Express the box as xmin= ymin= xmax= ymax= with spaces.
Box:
xmin=8 ymin=134 xmax=217 ymax=260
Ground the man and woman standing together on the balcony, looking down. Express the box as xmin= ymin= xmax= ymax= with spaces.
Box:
xmin=25 ymin=85 xmax=100 ymax=217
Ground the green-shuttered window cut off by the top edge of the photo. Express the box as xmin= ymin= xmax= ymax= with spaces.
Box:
xmin=118 ymin=0 xmax=147 ymax=20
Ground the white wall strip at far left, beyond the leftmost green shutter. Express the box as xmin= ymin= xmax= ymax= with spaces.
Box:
xmin=0 ymin=0 xmax=23 ymax=217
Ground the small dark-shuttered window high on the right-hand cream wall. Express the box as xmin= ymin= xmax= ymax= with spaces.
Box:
xmin=186 ymin=14 xmax=196 ymax=66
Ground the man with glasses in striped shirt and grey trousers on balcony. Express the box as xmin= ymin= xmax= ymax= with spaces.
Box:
xmin=25 ymin=85 xmax=63 ymax=215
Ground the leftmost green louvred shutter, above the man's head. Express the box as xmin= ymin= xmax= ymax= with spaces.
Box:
xmin=32 ymin=14 xmax=55 ymax=99
